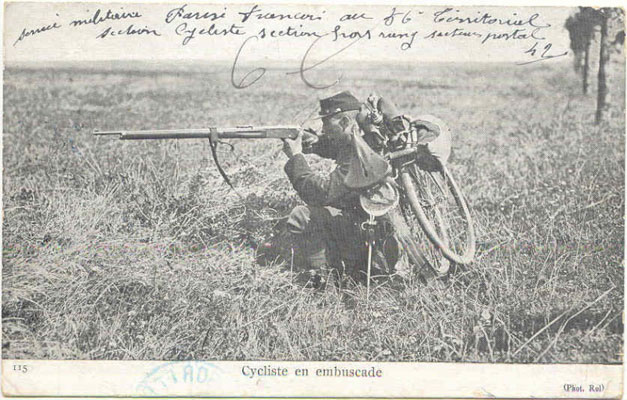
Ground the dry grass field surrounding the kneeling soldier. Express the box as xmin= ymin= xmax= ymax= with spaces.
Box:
xmin=2 ymin=62 xmax=625 ymax=363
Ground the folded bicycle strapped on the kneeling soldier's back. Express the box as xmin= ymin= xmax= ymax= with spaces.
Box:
xmin=361 ymin=98 xmax=476 ymax=275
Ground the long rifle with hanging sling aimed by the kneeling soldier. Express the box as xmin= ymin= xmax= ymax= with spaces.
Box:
xmin=94 ymin=126 xmax=304 ymax=190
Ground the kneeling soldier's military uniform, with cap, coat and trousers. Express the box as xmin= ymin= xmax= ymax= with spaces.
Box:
xmin=284 ymin=92 xmax=399 ymax=278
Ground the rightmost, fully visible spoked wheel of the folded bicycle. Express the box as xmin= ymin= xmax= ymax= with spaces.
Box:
xmin=400 ymin=164 xmax=475 ymax=273
